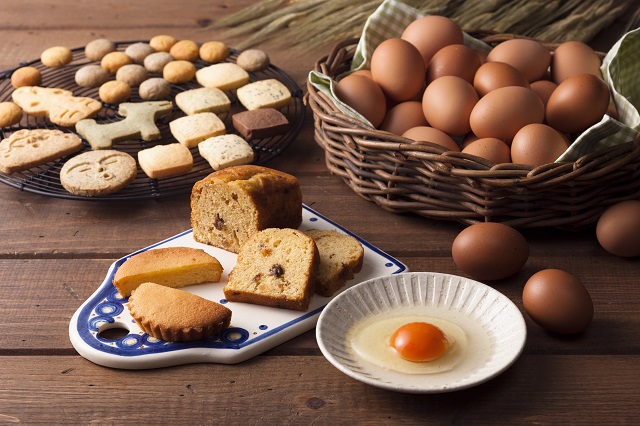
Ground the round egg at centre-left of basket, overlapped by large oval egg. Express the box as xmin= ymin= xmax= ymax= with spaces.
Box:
xmin=422 ymin=76 xmax=478 ymax=136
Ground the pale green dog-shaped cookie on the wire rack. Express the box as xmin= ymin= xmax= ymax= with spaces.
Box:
xmin=76 ymin=101 xmax=173 ymax=150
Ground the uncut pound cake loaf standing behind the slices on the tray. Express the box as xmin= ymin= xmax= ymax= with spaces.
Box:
xmin=191 ymin=165 xmax=302 ymax=253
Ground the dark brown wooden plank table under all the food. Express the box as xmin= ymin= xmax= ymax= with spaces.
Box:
xmin=0 ymin=0 xmax=640 ymax=424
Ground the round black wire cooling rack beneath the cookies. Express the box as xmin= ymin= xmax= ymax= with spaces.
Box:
xmin=0 ymin=40 xmax=305 ymax=201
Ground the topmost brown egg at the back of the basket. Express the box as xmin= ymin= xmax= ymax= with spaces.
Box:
xmin=401 ymin=15 xmax=464 ymax=66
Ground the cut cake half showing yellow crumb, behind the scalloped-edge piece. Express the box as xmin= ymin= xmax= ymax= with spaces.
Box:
xmin=113 ymin=247 xmax=222 ymax=297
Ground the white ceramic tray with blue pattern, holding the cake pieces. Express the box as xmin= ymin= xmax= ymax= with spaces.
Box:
xmin=69 ymin=206 xmax=407 ymax=369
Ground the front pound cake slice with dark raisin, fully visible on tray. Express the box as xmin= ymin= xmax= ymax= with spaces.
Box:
xmin=224 ymin=228 xmax=320 ymax=311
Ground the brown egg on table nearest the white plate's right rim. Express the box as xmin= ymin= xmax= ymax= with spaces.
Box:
xmin=522 ymin=269 xmax=593 ymax=334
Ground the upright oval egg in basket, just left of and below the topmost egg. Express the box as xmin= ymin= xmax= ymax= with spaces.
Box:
xmin=371 ymin=38 xmax=427 ymax=102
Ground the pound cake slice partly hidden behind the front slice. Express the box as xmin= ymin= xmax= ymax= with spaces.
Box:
xmin=306 ymin=229 xmax=364 ymax=297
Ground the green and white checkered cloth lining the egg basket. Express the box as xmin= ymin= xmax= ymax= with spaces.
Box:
xmin=309 ymin=0 xmax=640 ymax=161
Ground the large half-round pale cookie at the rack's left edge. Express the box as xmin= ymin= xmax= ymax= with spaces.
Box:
xmin=0 ymin=129 xmax=82 ymax=174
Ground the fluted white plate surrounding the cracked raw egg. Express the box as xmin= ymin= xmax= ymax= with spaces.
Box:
xmin=316 ymin=272 xmax=527 ymax=393
